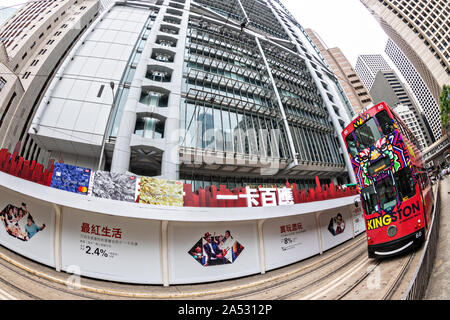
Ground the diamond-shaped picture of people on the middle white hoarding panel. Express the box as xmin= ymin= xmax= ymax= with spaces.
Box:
xmin=188 ymin=230 xmax=244 ymax=267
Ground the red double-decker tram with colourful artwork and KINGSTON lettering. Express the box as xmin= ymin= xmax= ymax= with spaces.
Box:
xmin=342 ymin=102 xmax=433 ymax=258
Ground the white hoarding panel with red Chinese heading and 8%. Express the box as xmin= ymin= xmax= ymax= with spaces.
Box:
xmin=263 ymin=214 xmax=319 ymax=270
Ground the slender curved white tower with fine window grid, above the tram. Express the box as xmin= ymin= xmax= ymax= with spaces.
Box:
xmin=385 ymin=39 xmax=442 ymax=142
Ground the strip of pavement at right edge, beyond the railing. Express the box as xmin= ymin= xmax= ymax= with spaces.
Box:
xmin=425 ymin=176 xmax=450 ymax=300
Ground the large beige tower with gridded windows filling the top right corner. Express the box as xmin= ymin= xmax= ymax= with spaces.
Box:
xmin=361 ymin=0 xmax=450 ymax=107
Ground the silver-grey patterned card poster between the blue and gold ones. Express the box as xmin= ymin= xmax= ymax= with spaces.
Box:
xmin=89 ymin=171 xmax=137 ymax=202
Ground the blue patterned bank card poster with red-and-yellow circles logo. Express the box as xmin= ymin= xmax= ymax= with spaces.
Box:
xmin=50 ymin=162 xmax=91 ymax=195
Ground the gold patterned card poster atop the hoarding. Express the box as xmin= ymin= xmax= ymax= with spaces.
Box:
xmin=138 ymin=177 xmax=184 ymax=207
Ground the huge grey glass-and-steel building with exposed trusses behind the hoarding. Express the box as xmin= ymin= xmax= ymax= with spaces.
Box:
xmin=1 ymin=0 xmax=354 ymax=188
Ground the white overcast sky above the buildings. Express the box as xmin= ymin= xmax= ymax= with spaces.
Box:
xmin=0 ymin=0 xmax=392 ymax=66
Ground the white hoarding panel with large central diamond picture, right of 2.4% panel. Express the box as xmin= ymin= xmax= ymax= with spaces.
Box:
xmin=168 ymin=221 xmax=260 ymax=284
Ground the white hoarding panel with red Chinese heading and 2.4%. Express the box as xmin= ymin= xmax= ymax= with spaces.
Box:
xmin=61 ymin=208 xmax=162 ymax=284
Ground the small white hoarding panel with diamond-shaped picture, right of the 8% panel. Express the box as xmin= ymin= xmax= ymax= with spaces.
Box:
xmin=319 ymin=206 xmax=353 ymax=251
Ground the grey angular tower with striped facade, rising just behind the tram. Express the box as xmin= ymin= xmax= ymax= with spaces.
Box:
xmin=370 ymin=70 xmax=431 ymax=149
